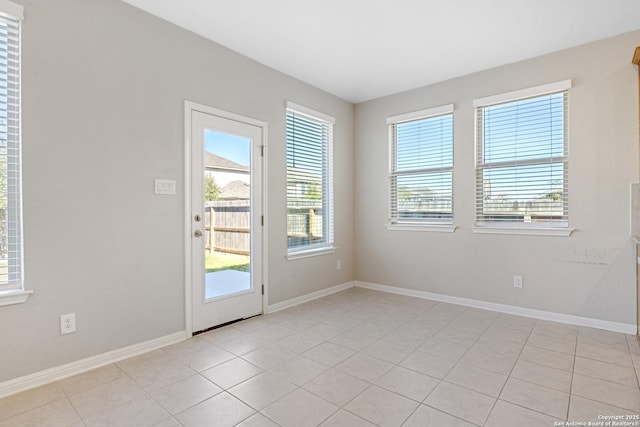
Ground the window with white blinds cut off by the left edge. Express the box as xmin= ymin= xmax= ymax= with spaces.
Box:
xmin=0 ymin=0 xmax=23 ymax=298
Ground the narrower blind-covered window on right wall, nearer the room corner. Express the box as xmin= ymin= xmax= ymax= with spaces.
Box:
xmin=387 ymin=105 xmax=453 ymax=231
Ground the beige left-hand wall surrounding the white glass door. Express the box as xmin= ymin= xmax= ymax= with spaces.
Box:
xmin=0 ymin=0 xmax=354 ymax=382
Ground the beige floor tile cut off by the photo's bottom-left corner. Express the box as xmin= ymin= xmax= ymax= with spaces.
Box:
xmin=0 ymin=399 xmax=81 ymax=427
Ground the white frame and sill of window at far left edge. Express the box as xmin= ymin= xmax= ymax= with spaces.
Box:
xmin=0 ymin=0 xmax=33 ymax=306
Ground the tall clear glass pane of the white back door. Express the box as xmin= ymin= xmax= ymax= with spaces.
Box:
xmin=203 ymin=129 xmax=252 ymax=299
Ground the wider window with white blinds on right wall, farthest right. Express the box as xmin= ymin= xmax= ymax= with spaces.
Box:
xmin=475 ymin=81 xmax=571 ymax=235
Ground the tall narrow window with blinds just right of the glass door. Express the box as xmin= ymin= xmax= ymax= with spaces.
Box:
xmin=287 ymin=103 xmax=335 ymax=257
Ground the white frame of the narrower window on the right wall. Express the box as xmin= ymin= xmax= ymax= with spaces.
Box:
xmin=386 ymin=104 xmax=457 ymax=233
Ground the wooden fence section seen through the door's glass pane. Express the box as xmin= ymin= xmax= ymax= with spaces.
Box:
xmin=204 ymin=200 xmax=251 ymax=255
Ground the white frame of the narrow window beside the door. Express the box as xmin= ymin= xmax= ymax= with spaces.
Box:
xmin=285 ymin=101 xmax=336 ymax=260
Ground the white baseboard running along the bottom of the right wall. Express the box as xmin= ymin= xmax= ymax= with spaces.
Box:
xmin=356 ymin=281 xmax=637 ymax=335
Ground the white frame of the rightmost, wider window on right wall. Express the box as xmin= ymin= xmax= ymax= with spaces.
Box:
xmin=472 ymin=79 xmax=574 ymax=237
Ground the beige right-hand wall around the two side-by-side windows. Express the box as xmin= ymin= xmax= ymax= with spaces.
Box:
xmin=355 ymin=32 xmax=640 ymax=325
